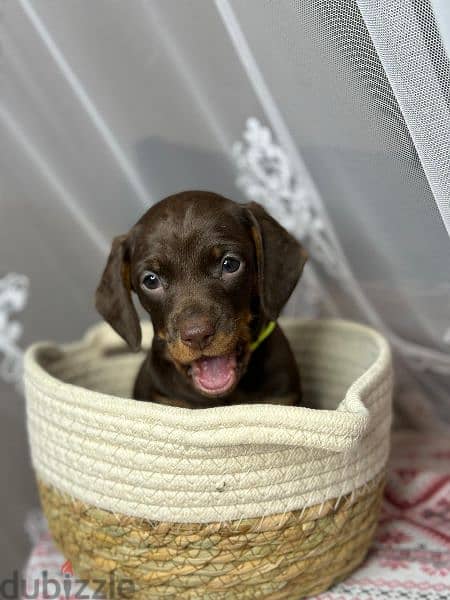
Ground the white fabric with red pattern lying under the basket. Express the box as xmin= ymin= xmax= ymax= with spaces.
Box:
xmin=25 ymin=433 xmax=450 ymax=600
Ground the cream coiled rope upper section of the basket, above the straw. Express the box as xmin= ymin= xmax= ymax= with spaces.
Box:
xmin=25 ymin=320 xmax=392 ymax=522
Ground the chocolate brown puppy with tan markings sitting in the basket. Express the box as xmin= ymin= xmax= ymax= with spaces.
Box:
xmin=96 ymin=191 xmax=306 ymax=408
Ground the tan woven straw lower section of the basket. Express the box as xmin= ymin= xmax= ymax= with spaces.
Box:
xmin=39 ymin=475 xmax=384 ymax=600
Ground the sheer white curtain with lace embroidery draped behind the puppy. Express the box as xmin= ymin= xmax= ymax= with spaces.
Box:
xmin=0 ymin=0 xmax=450 ymax=573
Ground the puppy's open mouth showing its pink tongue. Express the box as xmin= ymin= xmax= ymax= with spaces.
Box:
xmin=190 ymin=353 xmax=238 ymax=396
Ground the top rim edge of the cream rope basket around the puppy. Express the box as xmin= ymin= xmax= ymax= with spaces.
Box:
xmin=24 ymin=318 xmax=391 ymax=451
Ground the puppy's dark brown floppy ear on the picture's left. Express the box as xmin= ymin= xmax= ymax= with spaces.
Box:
xmin=95 ymin=235 xmax=141 ymax=352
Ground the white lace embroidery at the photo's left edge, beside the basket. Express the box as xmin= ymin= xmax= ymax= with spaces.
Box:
xmin=0 ymin=273 xmax=29 ymax=387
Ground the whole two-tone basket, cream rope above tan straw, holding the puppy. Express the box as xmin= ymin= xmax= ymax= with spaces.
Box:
xmin=25 ymin=321 xmax=392 ymax=600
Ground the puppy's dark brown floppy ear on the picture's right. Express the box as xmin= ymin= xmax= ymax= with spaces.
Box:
xmin=245 ymin=202 xmax=308 ymax=320
